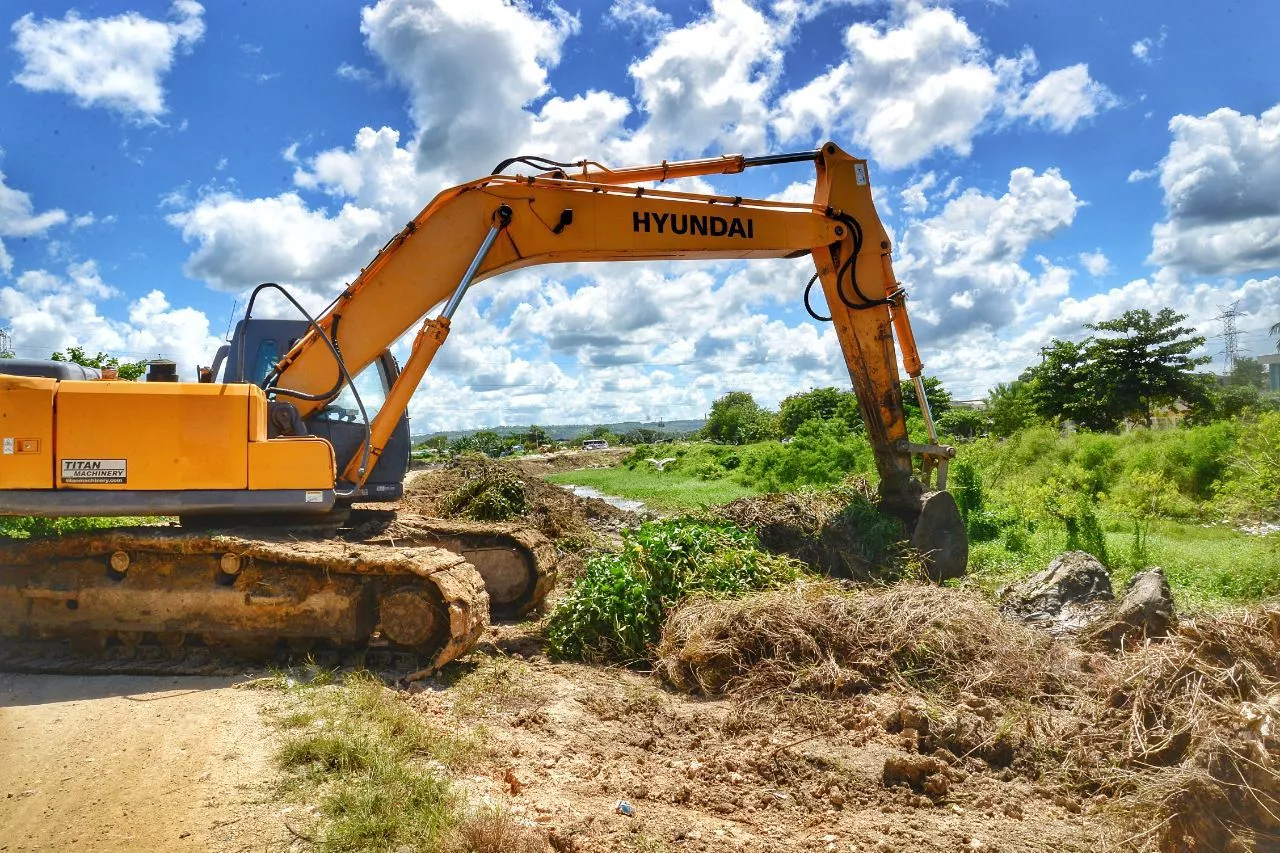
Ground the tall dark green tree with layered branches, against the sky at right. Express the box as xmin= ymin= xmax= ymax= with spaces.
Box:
xmin=1030 ymin=309 xmax=1210 ymax=429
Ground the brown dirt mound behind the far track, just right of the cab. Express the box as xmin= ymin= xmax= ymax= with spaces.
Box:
xmin=403 ymin=456 xmax=640 ymax=544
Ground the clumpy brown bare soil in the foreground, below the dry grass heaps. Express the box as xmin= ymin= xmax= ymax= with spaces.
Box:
xmin=408 ymin=625 xmax=1115 ymax=853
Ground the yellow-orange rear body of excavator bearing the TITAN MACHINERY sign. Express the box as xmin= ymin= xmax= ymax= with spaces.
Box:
xmin=0 ymin=377 xmax=335 ymax=515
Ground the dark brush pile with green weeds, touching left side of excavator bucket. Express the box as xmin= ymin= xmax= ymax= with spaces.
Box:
xmin=714 ymin=478 xmax=911 ymax=580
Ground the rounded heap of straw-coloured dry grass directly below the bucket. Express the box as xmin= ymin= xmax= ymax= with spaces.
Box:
xmin=658 ymin=583 xmax=1065 ymax=698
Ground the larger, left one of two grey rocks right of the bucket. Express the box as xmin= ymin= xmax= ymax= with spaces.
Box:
xmin=1000 ymin=551 xmax=1115 ymax=634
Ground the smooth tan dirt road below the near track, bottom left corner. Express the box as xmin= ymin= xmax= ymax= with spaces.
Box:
xmin=0 ymin=674 xmax=287 ymax=853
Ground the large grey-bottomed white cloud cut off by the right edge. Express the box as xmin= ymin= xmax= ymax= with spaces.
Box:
xmin=1148 ymin=105 xmax=1280 ymax=275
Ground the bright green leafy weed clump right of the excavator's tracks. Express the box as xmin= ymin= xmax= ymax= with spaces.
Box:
xmin=547 ymin=517 xmax=800 ymax=662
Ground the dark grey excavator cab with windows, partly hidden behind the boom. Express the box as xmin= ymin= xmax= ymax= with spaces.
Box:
xmin=209 ymin=318 xmax=411 ymax=503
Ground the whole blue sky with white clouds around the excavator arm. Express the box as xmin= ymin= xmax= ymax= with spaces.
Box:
xmin=0 ymin=0 xmax=1280 ymax=432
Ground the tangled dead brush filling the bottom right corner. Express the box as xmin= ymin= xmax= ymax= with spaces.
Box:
xmin=1066 ymin=607 xmax=1280 ymax=852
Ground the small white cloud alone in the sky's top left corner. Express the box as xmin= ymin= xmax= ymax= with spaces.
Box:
xmin=13 ymin=0 xmax=205 ymax=122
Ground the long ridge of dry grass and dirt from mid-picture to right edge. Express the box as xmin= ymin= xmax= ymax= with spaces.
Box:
xmin=658 ymin=584 xmax=1280 ymax=852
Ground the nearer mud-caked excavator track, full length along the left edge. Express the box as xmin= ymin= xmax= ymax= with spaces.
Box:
xmin=0 ymin=528 xmax=489 ymax=678
